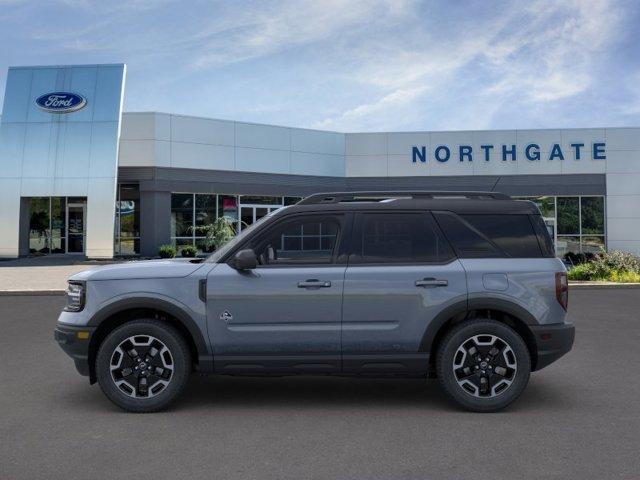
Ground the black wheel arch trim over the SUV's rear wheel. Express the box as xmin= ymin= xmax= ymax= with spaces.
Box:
xmin=420 ymin=298 xmax=538 ymax=372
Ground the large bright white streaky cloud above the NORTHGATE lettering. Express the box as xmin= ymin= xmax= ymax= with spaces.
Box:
xmin=316 ymin=0 xmax=621 ymax=130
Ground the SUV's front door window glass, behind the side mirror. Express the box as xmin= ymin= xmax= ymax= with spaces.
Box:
xmin=254 ymin=215 xmax=340 ymax=265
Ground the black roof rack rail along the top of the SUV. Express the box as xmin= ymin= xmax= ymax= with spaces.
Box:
xmin=297 ymin=190 xmax=511 ymax=205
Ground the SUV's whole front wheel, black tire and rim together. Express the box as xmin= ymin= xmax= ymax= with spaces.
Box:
xmin=96 ymin=319 xmax=191 ymax=413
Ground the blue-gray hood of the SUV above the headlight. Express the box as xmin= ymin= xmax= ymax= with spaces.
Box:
xmin=69 ymin=258 xmax=203 ymax=280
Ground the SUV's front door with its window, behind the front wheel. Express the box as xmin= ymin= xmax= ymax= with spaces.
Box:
xmin=207 ymin=214 xmax=346 ymax=374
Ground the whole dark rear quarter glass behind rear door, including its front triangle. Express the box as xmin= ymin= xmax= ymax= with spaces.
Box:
xmin=436 ymin=212 xmax=543 ymax=258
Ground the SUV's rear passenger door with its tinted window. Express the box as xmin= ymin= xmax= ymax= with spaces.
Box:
xmin=342 ymin=211 xmax=467 ymax=373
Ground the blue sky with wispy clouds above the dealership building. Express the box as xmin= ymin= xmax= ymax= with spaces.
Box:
xmin=0 ymin=0 xmax=640 ymax=132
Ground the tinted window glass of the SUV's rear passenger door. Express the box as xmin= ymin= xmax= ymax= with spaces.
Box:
xmin=351 ymin=212 xmax=454 ymax=263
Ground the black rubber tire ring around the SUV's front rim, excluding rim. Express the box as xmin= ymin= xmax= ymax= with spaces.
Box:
xmin=96 ymin=319 xmax=191 ymax=413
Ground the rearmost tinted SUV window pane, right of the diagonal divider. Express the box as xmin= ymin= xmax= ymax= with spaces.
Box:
xmin=461 ymin=214 xmax=542 ymax=258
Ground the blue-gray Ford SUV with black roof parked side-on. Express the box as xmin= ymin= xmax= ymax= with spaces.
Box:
xmin=55 ymin=191 xmax=574 ymax=412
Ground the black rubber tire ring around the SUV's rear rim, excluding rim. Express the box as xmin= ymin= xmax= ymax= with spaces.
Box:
xmin=436 ymin=319 xmax=531 ymax=412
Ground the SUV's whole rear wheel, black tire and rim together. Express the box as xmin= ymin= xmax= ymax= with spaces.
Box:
xmin=436 ymin=319 xmax=531 ymax=412
